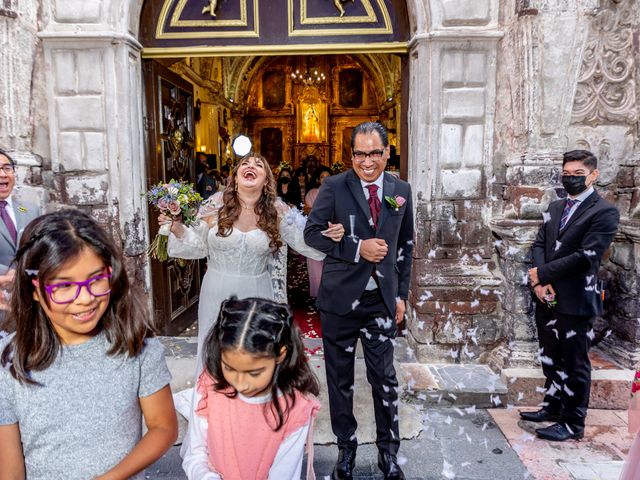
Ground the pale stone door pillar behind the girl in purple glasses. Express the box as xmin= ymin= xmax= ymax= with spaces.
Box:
xmin=38 ymin=0 xmax=147 ymax=266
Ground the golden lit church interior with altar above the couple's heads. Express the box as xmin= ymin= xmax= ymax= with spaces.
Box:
xmin=165 ymin=54 xmax=402 ymax=179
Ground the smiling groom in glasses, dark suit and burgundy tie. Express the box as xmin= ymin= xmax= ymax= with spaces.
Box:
xmin=304 ymin=122 xmax=413 ymax=480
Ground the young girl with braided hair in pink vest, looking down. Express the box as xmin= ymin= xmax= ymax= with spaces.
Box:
xmin=182 ymin=297 xmax=320 ymax=480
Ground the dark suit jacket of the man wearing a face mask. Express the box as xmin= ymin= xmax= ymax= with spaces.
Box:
xmin=533 ymin=191 xmax=620 ymax=317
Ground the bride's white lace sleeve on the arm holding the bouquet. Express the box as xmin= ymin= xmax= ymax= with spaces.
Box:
xmin=167 ymin=193 xmax=222 ymax=259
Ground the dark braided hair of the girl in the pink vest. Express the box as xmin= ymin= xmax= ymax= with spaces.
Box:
xmin=204 ymin=296 xmax=320 ymax=431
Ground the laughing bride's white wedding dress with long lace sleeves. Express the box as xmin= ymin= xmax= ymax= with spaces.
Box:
xmin=168 ymin=192 xmax=324 ymax=374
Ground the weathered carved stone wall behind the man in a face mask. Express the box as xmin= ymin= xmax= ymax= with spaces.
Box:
xmin=490 ymin=0 xmax=639 ymax=366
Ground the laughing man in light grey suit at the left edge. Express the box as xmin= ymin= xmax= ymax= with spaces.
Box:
xmin=0 ymin=149 xmax=40 ymax=310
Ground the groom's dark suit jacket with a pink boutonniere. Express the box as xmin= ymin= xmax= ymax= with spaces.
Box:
xmin=304 ymin=170 xmax=413 ymax=316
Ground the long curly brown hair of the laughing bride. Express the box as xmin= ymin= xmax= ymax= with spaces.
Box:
xmin=217 ymin=152 xmax=283 ymax=253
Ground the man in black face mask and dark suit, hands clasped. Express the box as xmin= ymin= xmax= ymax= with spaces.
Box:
xmin=520 ymin=150 xmax=620 ymax=441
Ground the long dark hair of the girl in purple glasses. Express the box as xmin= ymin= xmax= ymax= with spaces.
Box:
xmin=0 ymin=209 xmax=155 ymax=384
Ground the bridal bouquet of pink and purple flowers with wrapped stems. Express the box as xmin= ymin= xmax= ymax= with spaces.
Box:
xmin=147 ymin=179 xmax=202 ymax=262
